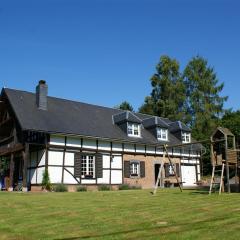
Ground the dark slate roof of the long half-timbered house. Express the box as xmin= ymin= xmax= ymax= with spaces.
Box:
xmin=2 ymin=88 xmax=200 ymax=149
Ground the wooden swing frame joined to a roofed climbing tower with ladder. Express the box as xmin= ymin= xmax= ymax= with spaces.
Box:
xmin=153 ymin=127 xmax=240 ymax=194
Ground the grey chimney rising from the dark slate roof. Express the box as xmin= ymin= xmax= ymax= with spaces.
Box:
xmin=36 ymin=80 xmax=48 ymax=111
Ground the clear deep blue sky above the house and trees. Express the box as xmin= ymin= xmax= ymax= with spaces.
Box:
xmin=0 ymin=0 xmax=240 ymax=110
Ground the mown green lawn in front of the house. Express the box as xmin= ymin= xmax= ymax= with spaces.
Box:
xmin=0 ymin=189 xmax=240 ymax=240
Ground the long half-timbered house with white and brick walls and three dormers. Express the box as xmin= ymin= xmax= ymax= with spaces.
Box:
xmin=0 ymin=80 xmax=201 ymax=191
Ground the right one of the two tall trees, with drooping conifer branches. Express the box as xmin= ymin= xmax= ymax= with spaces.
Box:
xmin=183 ymin=56 xmax=227 ymax=139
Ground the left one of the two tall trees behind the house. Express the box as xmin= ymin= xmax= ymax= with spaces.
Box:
xmin=139 ymin=56 xmax=185 ymax=120
